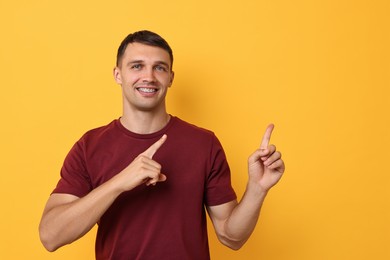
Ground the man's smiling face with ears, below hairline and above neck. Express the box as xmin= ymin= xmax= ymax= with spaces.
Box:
xmin=114 ymin=43 xmax=174 ymax=112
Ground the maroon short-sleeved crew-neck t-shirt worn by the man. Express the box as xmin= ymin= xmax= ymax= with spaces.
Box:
xmin=53 ymin=117 xmax=236 ymax=260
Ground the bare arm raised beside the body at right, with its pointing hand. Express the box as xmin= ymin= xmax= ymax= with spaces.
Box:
xmin=207 ymin=125 xmax=285 ymax=250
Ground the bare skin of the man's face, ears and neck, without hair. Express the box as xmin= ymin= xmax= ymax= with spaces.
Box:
xmin=114 ymin=43 xmax=174 ymax=134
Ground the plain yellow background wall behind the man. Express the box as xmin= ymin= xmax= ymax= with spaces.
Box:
xmin=0 ymin=0 xmax=390 ymax=260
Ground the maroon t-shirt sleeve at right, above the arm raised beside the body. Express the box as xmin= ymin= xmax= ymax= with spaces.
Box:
xmin=205 ymin=135 xmax=237 ymax=206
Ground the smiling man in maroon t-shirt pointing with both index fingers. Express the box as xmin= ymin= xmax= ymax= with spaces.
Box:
xmin=39 ymin=31 xmax=285 ymax=260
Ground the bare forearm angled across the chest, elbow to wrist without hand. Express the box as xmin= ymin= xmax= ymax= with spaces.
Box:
xmin=39 ymin=176 xmax=125 ymax=251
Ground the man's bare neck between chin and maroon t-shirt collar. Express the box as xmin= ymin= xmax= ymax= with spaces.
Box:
xmin=120 ymin=111 xmax=171 ymax=134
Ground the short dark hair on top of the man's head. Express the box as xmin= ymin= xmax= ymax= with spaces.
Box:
xmin=116 ymin=30 xmax=173 ymax=69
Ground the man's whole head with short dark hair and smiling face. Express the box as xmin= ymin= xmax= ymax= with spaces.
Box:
xmin=113 ymin=31 xmax=174 ymax=114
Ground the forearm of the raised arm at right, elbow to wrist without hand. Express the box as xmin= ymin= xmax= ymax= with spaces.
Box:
xmin=224 ymin=183 xmax=267 ymax=248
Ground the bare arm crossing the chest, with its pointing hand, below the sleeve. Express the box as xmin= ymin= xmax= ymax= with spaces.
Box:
xmin=39 ymin=135 xmax=166 ymax=251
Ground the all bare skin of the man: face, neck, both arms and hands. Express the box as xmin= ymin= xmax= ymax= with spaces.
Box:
xmin=39 ymin=43 xmax=285 ymax=251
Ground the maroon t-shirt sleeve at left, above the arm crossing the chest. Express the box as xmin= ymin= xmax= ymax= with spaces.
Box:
xmin=53 ymin=139 xmax=92 ymax=197
